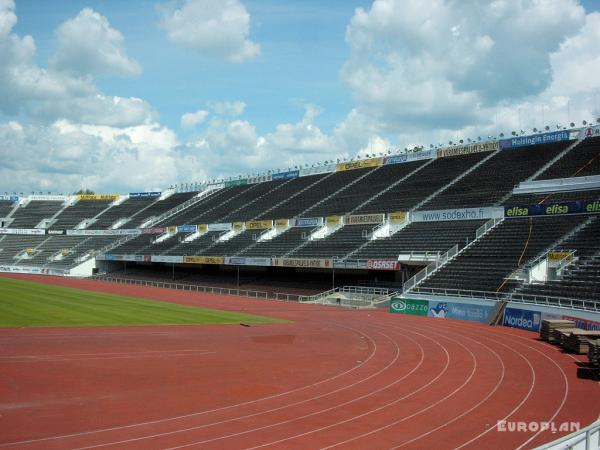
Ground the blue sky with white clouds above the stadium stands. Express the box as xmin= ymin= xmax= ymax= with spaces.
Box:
xmin=0 ymin=0 xmax=600 ymax=194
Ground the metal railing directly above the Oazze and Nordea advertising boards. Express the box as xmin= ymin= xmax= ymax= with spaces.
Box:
xmin=411 ymin=287 xmax=600 ymax=312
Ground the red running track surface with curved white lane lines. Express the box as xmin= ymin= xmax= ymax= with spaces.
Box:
xmin=0 ymin=277 xmax=600 ymax=449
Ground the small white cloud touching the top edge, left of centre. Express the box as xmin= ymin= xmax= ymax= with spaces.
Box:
xmin=162 ymin=0 xmax=260 ymax=63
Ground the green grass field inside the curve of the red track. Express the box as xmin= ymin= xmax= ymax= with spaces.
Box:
xmin=0 ymin=278 xmax=284 ymax=327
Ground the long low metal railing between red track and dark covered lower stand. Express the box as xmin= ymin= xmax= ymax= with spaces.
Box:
xmin=94 ymin=275 xmax=310 ymax=302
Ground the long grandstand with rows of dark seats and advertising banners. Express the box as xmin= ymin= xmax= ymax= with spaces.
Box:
xmin=0 ymin=127 xmax=600 ymax=300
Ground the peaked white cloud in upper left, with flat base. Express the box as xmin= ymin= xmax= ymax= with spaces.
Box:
xmin=51 ymin=8 xmax=142 ymax=75
